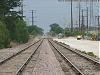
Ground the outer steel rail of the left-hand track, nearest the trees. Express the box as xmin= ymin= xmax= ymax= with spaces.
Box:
xmin=0 ymin=40 xmax=41 ymax=65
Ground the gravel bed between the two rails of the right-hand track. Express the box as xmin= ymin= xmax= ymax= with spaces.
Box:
xmin=50 ymin=40 xmax=100 ymax=75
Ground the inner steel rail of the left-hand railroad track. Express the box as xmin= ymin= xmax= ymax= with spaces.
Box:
xmin=16 ymin=40 xmax=43 ymax=75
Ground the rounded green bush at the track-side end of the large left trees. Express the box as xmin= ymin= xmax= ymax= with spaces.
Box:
xmin=15 ymin=20 xmax=29 ymax=43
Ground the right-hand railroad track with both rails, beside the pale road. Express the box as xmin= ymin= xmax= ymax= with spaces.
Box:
xmin=49 ymin=39 xmax=100 ymax=75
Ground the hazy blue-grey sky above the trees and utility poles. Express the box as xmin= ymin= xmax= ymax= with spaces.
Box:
xmin=23 ymin=0 xmax=99 ymax=32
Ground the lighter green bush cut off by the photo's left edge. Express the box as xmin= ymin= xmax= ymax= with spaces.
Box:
xmin=0 ymin=21 xmax=10 ymax=48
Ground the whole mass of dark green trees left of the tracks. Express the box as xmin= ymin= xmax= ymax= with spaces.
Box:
xmin=0 ymin=0 xmax=43 ymax=48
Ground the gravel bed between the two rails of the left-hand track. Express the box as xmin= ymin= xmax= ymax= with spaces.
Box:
xmin=0 ymin=42 xmax=40 ymax=75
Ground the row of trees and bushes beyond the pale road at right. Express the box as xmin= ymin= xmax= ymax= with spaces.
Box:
xmin=48 ymin=23 xmax=100 ymax=40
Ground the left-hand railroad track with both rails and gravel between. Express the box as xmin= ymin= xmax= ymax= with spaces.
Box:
xmin=0 ymin=40 xmax=43 ymax=75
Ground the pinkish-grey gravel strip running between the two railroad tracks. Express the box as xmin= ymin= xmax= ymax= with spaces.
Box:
xmin=33 ymin=40 xmax=64 ymax=75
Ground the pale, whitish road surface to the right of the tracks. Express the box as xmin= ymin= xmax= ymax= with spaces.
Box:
xmin=54 ymin=37 xmax=100 ymax=57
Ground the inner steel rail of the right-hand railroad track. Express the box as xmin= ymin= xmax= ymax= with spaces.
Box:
xmin=48 ymin=40 xmax=85 ymax=75
